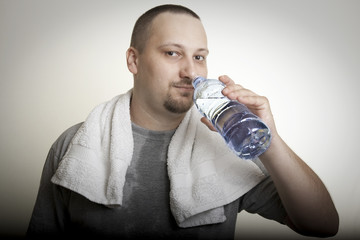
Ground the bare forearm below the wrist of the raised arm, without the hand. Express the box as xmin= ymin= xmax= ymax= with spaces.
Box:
xmin=260 ymin=135 xmax=339 ymax=237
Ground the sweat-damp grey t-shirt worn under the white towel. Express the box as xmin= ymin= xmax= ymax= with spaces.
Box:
xmin=28 ymin=124 xmax=286 ymax=239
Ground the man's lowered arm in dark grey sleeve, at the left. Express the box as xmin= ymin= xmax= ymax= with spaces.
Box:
xmin=27 ymin=123 xmax=82 ymax=238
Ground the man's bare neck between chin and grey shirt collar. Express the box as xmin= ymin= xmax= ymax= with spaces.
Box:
xmin=130 ymin=95 xmax=186 ymax=131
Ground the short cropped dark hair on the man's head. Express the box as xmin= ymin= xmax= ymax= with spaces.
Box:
xmin=130 ymin=4 xmax=200 ymax=53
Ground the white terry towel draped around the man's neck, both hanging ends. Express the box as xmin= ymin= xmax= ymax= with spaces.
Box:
xmin=51 ymin=90 xmax=265 ymax=227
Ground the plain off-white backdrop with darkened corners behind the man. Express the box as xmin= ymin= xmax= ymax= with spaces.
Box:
xmin=0 ymin=0 xmax=360 ymax=239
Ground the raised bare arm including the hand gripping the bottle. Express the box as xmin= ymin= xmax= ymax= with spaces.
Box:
xmin=202 ymin=76 xmax=339 ymax=236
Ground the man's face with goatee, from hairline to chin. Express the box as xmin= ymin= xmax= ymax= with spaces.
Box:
xmin=130 ymin=13 xmax=208 ymax=114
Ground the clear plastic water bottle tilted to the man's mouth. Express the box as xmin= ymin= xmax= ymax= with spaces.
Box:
xmin=193 ymin=77 xmax=271 ymax=159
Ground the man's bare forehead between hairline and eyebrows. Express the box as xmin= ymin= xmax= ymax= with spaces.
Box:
xmin=148 ymin=12 xmax=207 ymax=48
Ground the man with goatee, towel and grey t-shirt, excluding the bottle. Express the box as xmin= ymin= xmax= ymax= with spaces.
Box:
xmin=28 ymin=5 xmax=339 ymax=239
